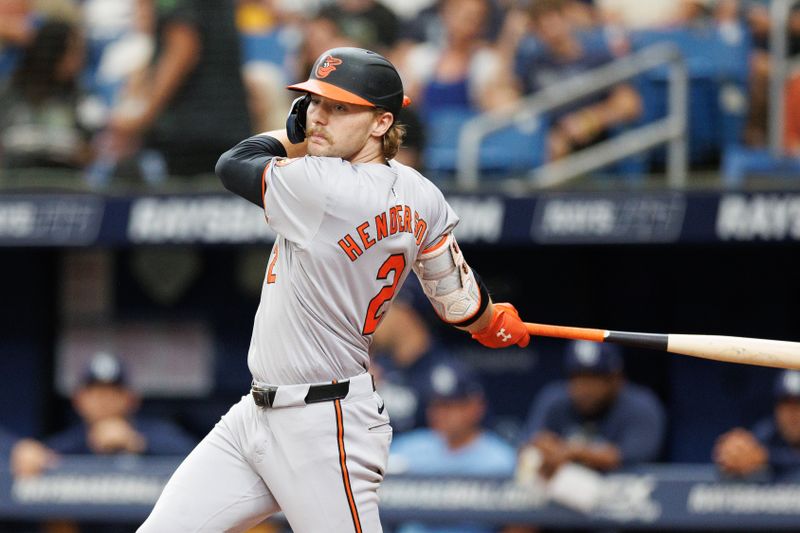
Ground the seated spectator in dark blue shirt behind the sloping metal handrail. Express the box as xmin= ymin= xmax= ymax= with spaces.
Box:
xmin=506 ymin=0 xmax=642 ymax=159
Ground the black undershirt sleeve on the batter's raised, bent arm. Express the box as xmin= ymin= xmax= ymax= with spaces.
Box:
xmin=214 ymin=135 xmax=286 ymax=208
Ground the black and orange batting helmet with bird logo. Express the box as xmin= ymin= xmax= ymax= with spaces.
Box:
xmin=288 ymin=47 xmax=411 ymax=117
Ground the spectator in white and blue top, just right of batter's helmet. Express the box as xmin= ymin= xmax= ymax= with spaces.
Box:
xmin=399 ymin=0 xmax=519 ymax=114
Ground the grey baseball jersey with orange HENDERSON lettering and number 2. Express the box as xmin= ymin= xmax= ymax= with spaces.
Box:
xmin=253 ymin=156 xmax=458 ymax=385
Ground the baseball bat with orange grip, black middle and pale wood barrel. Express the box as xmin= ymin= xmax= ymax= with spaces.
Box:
xmin=525 ymin=322 xmax=800 ymax=370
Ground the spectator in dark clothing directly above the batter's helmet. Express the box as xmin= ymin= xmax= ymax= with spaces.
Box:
xmin=321 ymin=0 xmax=399 ymax=53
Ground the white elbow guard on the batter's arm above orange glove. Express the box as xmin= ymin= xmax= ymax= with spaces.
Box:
xmin=414 ymin=234 xmax=489 ymax=327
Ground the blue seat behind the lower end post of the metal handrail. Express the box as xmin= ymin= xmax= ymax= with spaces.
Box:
xmin=424 ymin=109 xmax=546 ymax=178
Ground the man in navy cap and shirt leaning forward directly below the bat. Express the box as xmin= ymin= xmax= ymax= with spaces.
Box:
xmin=521 ymin=341 xmax=665 ymax=478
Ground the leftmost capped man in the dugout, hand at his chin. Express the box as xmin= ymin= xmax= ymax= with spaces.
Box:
xmin=13 ymin=352 xmax=196 ymax=475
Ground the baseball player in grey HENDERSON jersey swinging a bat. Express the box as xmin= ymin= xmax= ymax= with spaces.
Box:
xmin=139 ymin=48 xmax=529 ymax=533
